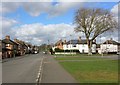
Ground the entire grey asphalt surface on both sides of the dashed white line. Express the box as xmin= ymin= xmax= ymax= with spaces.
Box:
xmin=2 ymin=53 xmax=76 ymax=85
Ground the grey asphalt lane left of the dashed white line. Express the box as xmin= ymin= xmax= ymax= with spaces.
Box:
xmin=2 ymin=53 xmax=44 ymax=83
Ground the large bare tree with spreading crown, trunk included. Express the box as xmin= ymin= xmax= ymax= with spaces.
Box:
xmin=75 ymin=8 xmax=117 ymax=54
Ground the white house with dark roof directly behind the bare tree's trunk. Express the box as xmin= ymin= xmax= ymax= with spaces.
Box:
xmin=63 ymin=37 xmax=96 ymax=53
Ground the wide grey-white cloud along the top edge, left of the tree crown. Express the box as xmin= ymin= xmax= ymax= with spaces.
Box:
xmin=23 ymin=1 xmax=82 ymax=17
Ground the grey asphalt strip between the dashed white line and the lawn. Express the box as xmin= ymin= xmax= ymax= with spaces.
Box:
xmin=40 ymin=54 xmax=77 ymax=83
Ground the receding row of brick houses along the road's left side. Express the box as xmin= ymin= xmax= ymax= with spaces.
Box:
xmin=0 ymin=36 xmax=38 ymax=59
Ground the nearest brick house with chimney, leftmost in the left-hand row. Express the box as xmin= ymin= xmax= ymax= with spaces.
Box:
xmin=2 ymin=36 xmax=18 ymax=58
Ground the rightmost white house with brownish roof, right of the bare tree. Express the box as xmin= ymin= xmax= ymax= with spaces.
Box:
xmin=98 ymin=38 xmax=120 ymax=54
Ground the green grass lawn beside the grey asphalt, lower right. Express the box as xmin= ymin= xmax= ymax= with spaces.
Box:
xmin=55 ymin=57 xmax=118 ymax=83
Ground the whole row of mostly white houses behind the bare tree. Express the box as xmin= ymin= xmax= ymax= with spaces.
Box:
xmin=53 ymin=37 xmax=120 ymax=54
